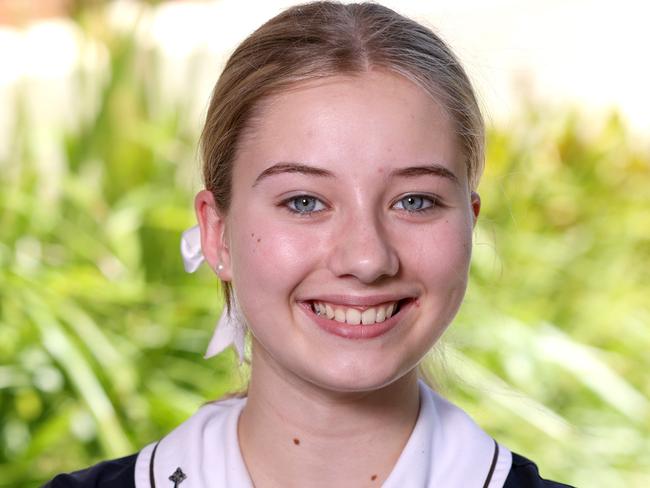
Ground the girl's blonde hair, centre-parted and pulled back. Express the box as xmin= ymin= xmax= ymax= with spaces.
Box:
xmin=201 ymin=2 xmax=485 ymax=309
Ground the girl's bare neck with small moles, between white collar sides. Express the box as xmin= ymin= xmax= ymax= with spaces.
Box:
xmin=239 ymin=351 xmax=419 ymax=488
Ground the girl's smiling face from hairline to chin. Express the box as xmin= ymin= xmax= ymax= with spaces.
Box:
xmin=197 ymin=71 xmax=479 ymax=391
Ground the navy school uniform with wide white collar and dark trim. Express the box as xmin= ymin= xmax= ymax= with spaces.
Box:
xmin=45 ymin=382 xmax=567 ymax=488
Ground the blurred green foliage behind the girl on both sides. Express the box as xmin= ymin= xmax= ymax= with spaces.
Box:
xmin=0 ymin=2 xmax=650 ymax=487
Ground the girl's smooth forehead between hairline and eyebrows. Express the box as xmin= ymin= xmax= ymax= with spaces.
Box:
xmin=233 ymin=71 xmax=466 ymax=185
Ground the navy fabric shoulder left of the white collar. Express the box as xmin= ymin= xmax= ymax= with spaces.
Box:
xmin=43 ymin=454 xmax=138 ymax=488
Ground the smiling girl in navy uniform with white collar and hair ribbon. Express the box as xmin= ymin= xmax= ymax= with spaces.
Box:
xmin=49 ymin=2 xmax=561 ymax=488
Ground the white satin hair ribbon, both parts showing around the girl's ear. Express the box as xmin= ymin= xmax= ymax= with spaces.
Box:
xmin=181 ymin=225 xmax=246 ymax=364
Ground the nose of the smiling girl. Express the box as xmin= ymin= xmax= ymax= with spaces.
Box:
xmin=328 ymin=212 xmax=399 ymax=284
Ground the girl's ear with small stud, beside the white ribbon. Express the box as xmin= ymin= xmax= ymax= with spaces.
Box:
xmin=194 ymin=190 xmax=232 ymax=281
